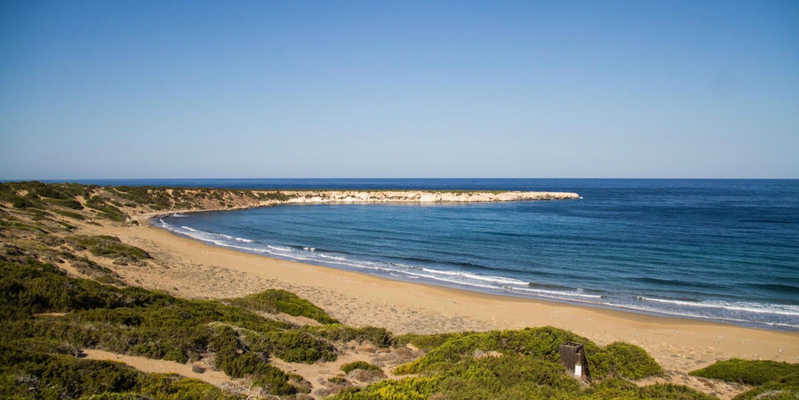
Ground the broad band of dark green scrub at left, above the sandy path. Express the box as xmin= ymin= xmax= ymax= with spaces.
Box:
xmin=0 ymin=261 xmax=326 ymax=394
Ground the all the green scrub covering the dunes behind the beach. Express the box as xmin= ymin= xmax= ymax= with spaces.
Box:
xmin=0 ymin=182 xmax=799 ymax=400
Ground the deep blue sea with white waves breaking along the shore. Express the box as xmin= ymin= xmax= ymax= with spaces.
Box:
xmin=53 ymin=179 xmax=799 ymax=330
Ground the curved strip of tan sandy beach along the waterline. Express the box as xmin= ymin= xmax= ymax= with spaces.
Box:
xmin=85 ymin=214 xmax=799 ymax=374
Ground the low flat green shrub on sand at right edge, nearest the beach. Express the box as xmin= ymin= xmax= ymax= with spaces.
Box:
xmin=690 ymin=358 xmax=799 ymax=386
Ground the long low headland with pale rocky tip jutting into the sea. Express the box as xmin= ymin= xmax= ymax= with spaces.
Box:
xmin=0 ymin=181 xmax=580 ymax=223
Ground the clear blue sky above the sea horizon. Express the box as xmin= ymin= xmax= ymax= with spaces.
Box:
xmin=0 ymin=0 xmax=799 ymax=179
